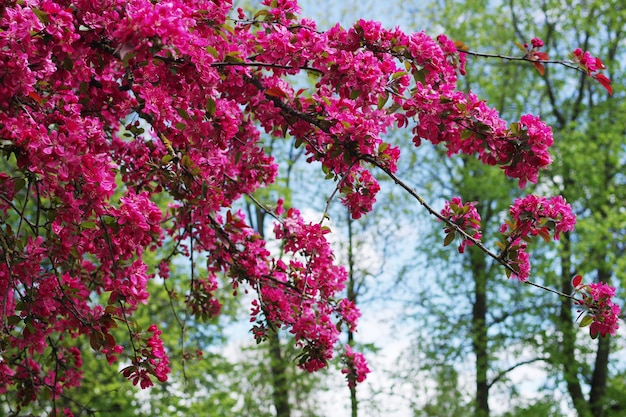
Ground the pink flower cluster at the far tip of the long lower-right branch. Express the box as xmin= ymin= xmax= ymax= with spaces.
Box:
xmin=572 ymin=275 xmax=621 ymax=339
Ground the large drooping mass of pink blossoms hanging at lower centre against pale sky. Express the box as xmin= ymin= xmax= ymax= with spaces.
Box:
xmin=268 ymin=208 xmax=360 ymax=372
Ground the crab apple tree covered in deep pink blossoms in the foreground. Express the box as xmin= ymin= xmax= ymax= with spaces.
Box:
xmin=0 ymin=0 xmax=619 ymax=414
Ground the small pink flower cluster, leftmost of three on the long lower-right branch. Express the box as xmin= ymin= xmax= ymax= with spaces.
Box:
xmin=440 ymin=197 xmax=482 ymax=253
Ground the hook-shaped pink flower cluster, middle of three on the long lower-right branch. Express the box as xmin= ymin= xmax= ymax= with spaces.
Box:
xmin=500 ymin=194 xmax=576 ymax=281
